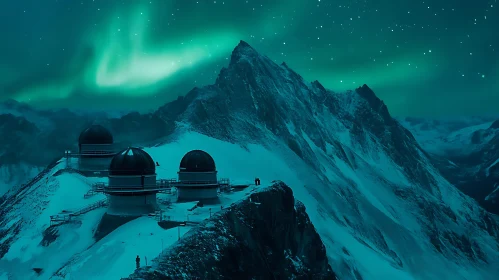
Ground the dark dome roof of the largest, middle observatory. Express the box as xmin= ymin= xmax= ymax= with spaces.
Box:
xmin=109 ymin=148 xmax=156 ymax=176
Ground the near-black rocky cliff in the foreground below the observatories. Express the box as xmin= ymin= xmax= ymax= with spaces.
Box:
xmin=128 ymin=182 xmax=336 ymax=280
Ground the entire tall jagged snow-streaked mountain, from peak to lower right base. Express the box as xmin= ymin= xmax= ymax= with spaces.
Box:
xmin=157 ymin=43 xmax=498 ymax=279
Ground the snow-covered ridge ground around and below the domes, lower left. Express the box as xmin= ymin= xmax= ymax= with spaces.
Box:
xmin=0 ymin=154 xmax=265 ymax=279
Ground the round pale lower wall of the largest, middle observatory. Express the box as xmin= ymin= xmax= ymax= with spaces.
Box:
xmin=107 ymin=193 xmax=158 ymax=216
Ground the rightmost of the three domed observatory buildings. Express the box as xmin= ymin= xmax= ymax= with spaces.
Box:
xmin=175 ymin=150 xmax=219 ymax=201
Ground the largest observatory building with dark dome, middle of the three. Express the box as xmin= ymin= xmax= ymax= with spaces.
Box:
xmin=102 ymin=148 xmax=160 ymax=216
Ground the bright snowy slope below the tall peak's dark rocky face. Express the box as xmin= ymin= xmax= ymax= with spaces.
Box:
xmin=148 ymin=133 xmax=498 ymax=279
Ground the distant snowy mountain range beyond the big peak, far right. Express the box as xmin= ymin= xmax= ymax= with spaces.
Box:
xmin=401 ymin=117 xmax=499 ymax=214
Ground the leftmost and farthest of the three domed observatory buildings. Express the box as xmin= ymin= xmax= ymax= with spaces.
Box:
xmin=78 ymin=125 xmax=116 ymax=176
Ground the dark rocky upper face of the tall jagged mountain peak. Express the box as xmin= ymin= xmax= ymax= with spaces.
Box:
xmin=156 ymin=41 xmax=436 ymax=191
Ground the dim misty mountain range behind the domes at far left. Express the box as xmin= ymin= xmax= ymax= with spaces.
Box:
xmin=0 ymin=100 xmax=174 ymax=194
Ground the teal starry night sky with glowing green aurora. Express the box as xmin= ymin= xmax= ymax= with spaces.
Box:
xmin=0 ymin=0 xmax=499 ymax=117
